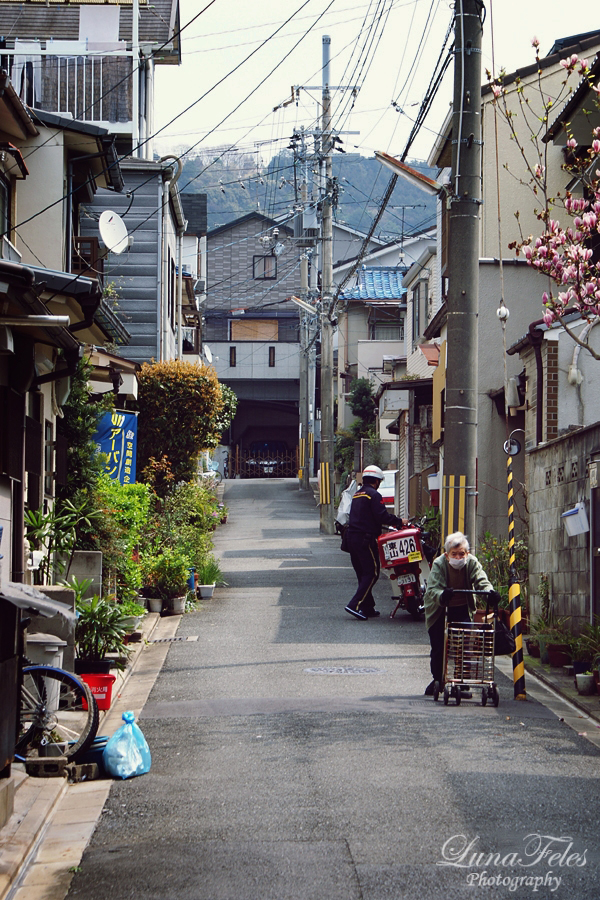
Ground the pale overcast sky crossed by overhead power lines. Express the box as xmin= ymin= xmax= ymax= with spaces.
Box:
xmin=155 ymin=0 xmax=600 ymax=166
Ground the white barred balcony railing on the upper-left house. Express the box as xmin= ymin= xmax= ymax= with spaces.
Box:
xmin=36 ymin=56 xmax=132 ymax=122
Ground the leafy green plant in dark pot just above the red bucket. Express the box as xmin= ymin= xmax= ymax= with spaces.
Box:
xmin=75 ymin=594 xmax=128 ymax=674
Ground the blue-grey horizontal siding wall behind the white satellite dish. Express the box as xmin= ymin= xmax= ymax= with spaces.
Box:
xmin=81 ymin=169 xmax=160 ymax=363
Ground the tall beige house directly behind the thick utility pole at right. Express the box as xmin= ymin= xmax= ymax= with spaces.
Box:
xmin=414 ymin=32 xmax=599 ymax=564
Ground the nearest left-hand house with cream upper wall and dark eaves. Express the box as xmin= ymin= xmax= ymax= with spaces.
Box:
xmin=0 ymin=88 xmax=127 ymax=822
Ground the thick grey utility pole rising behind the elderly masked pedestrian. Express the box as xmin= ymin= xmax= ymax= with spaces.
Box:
xmin=442 ymin=0 xmax=483 ymax=540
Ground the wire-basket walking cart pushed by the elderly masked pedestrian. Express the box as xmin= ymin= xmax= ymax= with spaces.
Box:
xmin=433 ymin=591 xmax=500 ymax=706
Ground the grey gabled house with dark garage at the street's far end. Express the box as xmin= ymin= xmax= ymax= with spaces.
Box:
xmin=203 ymin=212 xmax=301 ymax=475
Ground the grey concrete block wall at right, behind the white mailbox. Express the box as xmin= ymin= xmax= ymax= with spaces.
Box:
xmin=528 ymin=423 xmax=600 ymax=632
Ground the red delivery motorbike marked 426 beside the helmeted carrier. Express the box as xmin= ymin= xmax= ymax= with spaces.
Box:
xmin=377 ymin=522 xmax=436 ymax=621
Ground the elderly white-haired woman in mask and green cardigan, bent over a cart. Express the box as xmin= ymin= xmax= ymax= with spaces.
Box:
xmin=424 ymin=531 xmax=500 ymax=696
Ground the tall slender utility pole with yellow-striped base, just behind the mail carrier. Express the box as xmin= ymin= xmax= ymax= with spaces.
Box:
xmin=320 ymin=35 xmax=335 ymax=534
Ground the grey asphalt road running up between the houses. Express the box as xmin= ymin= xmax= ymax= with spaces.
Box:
xmin=69 ymin=479 xmax=600 ymax=900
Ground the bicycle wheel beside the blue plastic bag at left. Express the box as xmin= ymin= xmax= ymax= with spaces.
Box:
xmin=15 ymin=666 xmax=98 ymax=759
